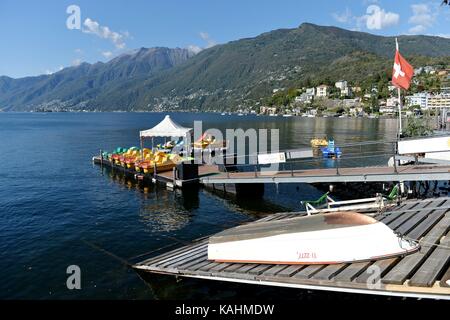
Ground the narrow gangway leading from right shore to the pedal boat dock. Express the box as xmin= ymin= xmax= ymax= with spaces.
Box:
xmin=200 ymin=164 xmax=450 ymax=183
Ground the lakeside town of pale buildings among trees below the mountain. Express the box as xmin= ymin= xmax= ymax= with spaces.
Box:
xmin=251 ymin=66 xmax=450 ymax=117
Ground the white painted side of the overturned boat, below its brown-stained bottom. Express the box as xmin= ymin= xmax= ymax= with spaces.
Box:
xmin=208 ymin=214 xmax=420 ymax=264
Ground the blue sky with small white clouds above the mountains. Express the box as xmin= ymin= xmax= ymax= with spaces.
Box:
xmin=0 ymin=0 xmax=450 ymax=77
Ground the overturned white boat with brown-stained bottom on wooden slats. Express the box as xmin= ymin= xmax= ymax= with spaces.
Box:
xmin=208 ymin=212 xmax=420 ymax=264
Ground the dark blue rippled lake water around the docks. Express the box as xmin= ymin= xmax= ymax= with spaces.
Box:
xmin=0 ymin=113 xmax=396 ymax=299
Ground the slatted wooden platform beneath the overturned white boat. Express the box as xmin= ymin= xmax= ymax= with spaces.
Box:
xmin=134 ymin=197 xmax=450 ymax=300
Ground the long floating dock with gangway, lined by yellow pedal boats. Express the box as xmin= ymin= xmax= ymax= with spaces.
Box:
xmin=93 ymin=156 xmax=450 ymax=189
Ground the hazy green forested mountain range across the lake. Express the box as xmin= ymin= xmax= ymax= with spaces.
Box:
xmin=0 ymin=23 xmax=450 ymax=111
